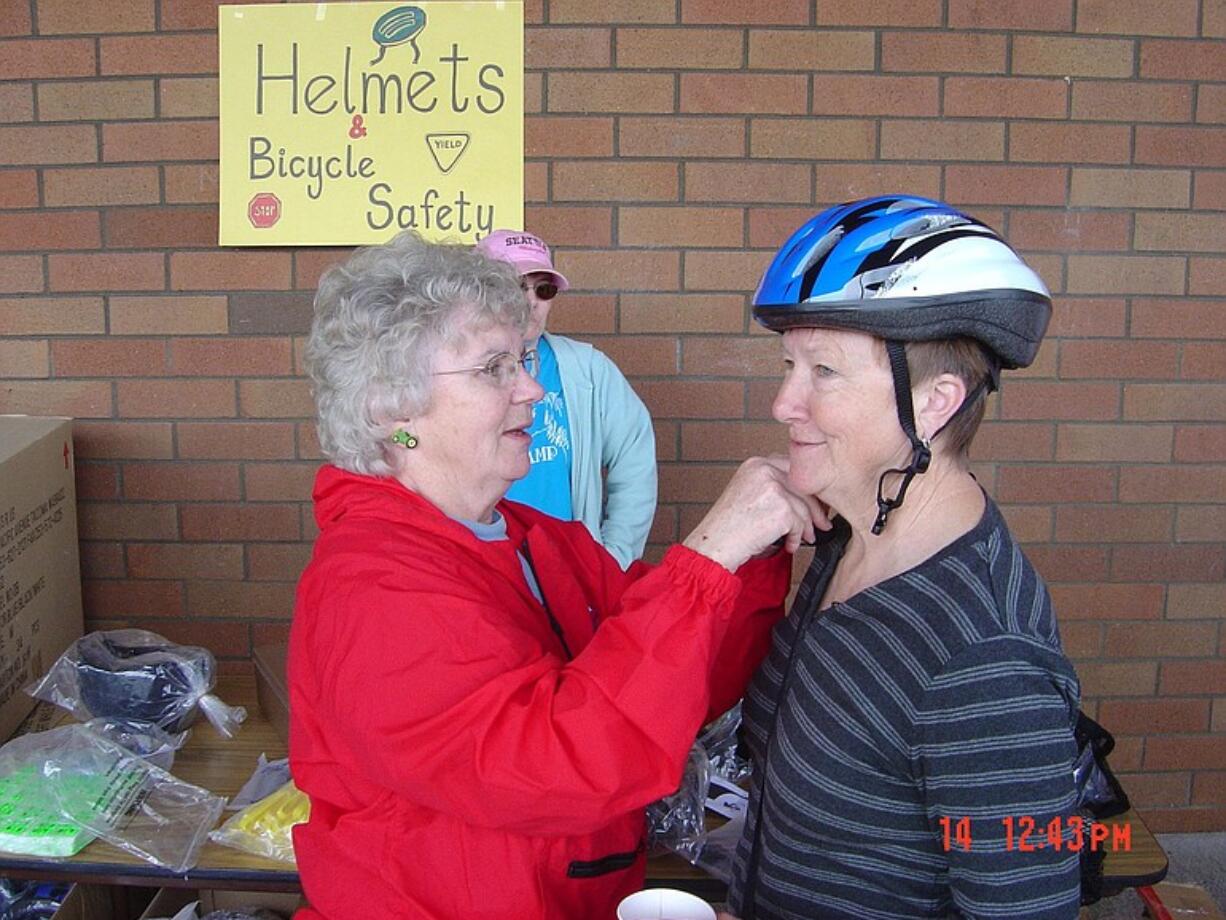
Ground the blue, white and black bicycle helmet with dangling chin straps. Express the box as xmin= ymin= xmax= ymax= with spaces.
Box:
xmin=753 ymin=195 xmax=1052 ymax=534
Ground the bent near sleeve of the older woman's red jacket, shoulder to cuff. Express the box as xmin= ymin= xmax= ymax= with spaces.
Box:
xmin=295 ymin=547 xmax=761 ymax=834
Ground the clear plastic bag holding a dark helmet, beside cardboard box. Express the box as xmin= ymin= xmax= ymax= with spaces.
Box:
xmin=26 ymin=629 xmax=246 ymax=738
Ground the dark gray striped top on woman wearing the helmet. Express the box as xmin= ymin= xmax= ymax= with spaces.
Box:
xmin=729 ymin=499 xmax=1079 ymax=920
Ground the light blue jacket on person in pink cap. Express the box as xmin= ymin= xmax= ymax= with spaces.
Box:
xmin=544 ymin=332 xmax=656 ymax=568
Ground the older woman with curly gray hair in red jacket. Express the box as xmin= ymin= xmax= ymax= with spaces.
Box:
xmin=289 ymin=234 xmax=826 ymax=920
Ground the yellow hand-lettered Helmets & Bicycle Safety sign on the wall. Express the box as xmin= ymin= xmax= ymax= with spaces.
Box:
xmin=218 ymin=0 xmax=524 ymax=247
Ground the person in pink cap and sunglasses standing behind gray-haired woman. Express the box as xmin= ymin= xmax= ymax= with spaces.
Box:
xmin=477 ymin=229 xmax=656 ymax=569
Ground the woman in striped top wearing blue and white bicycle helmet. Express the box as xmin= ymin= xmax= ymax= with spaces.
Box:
xmin=729 ymin=196 xmax=1089 ymax=920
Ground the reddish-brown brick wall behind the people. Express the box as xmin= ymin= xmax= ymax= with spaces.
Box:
xmin=0 ymin=0 xmax=1226 ymax=829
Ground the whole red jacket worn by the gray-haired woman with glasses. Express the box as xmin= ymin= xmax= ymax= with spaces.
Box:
xmin=289 ymin=466 xmax=791 ymax=920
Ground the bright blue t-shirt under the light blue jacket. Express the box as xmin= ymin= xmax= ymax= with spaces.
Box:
xmin=506 ymin=336 xmax=573 ymax=520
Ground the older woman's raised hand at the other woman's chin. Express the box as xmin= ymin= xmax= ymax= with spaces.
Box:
xmin=684 ymin=456 xmax=831 ymax=572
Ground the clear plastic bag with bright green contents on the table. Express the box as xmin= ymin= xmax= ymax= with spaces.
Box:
xmin=0 ymin=725 xmax=226 ymax=872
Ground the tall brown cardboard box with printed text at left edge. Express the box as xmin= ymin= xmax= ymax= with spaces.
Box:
xmin=0 ymin=416 xmax=83 ymax=741
